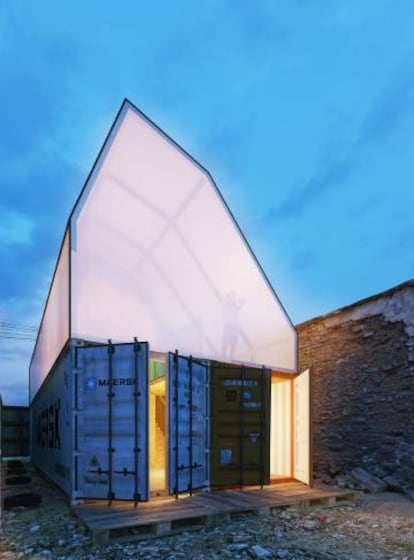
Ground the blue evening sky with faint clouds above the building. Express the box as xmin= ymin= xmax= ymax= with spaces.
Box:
xmin=0 ymin=0 xmax=414 ymax=404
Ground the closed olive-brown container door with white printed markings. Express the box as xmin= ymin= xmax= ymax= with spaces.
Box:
xmin=210 ymin=363 xmax=270 ymax=488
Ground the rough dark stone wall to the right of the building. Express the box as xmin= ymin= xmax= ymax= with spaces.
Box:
xmin=297 ymin=281 xmax=414 ymax=496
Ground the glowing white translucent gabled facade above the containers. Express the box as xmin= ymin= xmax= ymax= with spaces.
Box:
xmin=31 ymin=101 xmax=296 ymax=396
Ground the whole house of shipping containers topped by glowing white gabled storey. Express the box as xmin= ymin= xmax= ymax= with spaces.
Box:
xmin=30 ymin=97 xmax=311 ymax=502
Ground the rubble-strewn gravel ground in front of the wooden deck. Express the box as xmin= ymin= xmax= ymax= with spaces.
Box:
xmin=0 ymin=468 xmax=414 ymax=560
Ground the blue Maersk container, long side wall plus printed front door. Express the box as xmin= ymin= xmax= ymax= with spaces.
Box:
xmin=30 ymin=343 xmax=148 ymax=501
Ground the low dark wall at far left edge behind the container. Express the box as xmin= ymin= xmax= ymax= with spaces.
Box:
xmin=1 ymin=405 xmax=29 ymax=457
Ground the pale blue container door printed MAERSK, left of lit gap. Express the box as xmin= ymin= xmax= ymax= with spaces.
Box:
xmin=75 ymin=342 xmax=148 ymax=502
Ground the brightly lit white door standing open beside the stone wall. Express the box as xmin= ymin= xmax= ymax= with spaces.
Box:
xmin=293 ymin=369 xmax=312 ymax=484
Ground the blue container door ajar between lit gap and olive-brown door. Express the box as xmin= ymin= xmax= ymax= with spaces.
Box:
xmin=168 ymin=353 xmax=209 ymax=495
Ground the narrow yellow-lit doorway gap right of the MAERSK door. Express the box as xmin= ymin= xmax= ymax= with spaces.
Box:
xmin=149 ymin=352 xmax=167 ymax=496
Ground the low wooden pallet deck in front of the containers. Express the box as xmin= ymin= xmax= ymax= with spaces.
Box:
xmin=73 ymin=482 xmax=359 ymax=544
